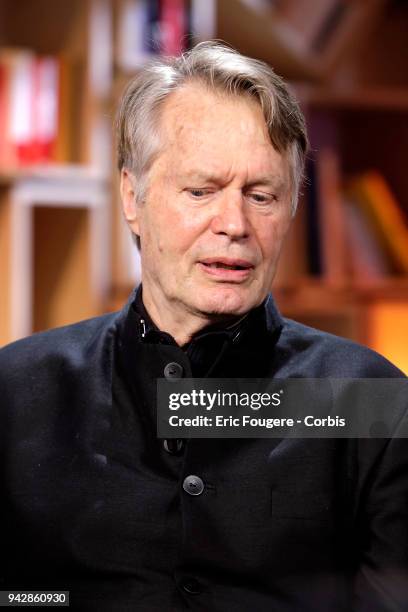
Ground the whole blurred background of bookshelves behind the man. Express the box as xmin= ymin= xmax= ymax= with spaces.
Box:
xmin=0 ymin=0 xmax=408 ymax=372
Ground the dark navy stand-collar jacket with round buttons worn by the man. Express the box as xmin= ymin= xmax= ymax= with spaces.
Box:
xmin=0 ymin=290 xmax=408 ymax=612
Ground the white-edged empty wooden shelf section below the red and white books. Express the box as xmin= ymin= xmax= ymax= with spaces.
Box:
xmin=0 ymin=168 xmax=110 ymax=344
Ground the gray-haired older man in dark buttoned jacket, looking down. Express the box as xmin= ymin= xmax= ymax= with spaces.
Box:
xmin=0 ymin=43 xmax=408 ymax=612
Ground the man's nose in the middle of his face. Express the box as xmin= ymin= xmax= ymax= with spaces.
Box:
xmin=211 ymin=193 xmax=249 ymax=240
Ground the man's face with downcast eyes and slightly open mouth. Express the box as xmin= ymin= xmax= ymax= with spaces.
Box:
xmin=124 ymin=84 xmax=291 ymax=322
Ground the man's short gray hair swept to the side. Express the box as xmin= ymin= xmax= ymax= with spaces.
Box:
xmin=116 ymin=41 xmax=307 ymax=213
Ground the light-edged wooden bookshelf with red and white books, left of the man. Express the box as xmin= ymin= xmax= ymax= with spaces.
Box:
xmin=0 ymin=0 xmax=112 ymax=345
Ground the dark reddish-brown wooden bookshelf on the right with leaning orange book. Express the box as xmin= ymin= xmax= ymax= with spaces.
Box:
xmin=275 ymin=2 xmax=408 ymax=372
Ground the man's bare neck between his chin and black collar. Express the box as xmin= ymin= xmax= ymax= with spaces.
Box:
xmin=142 ymin=287 xmax=243 ymax=346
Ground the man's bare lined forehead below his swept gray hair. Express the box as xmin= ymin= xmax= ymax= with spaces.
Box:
xmin=159 ymin=83 xmax=283 ymax=177
